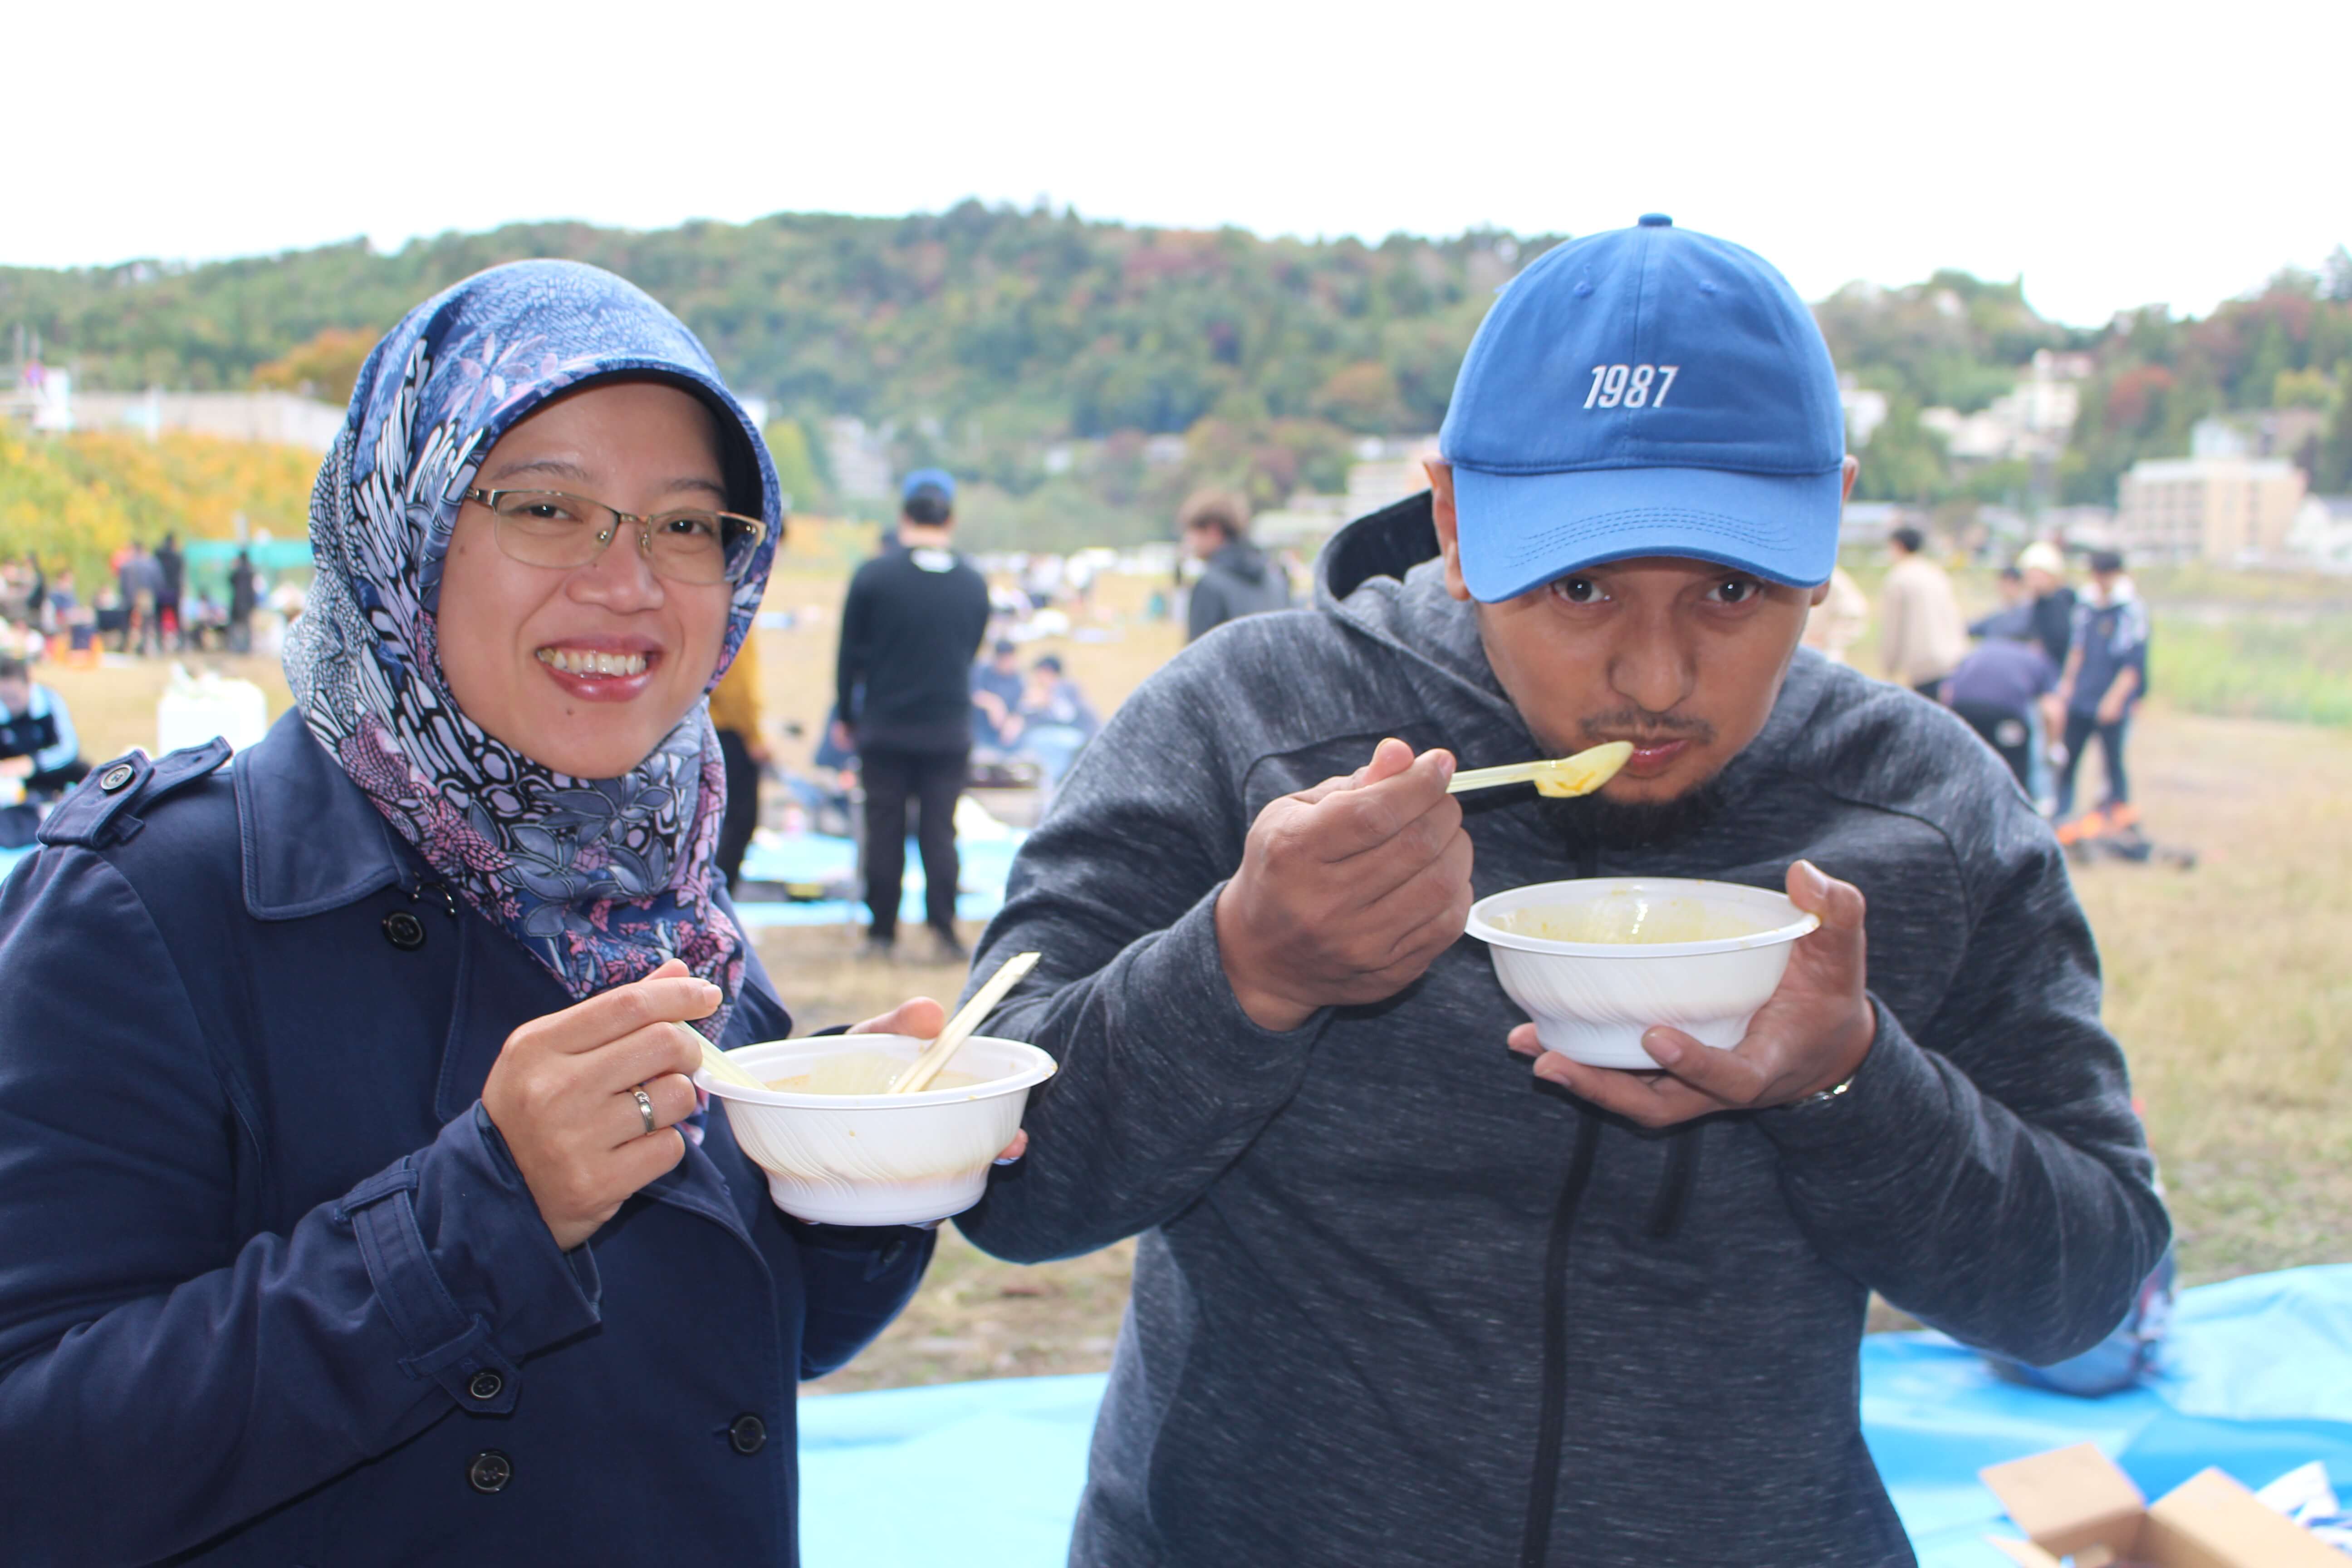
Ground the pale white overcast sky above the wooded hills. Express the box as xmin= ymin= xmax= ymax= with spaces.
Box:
xmin=0 ymin=0 xmax=2352 ymax=324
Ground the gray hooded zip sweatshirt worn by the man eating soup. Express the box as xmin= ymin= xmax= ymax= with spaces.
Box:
xmin=960 ymin=498 xmax=2169 ymax=1568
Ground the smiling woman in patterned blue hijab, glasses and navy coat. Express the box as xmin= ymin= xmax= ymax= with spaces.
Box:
xmin=0 ymin=261 xmax=983 ymax=1563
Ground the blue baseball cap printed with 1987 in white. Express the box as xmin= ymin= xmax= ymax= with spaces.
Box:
xmin=1437 ymin=211 xmax=1846 ymax=604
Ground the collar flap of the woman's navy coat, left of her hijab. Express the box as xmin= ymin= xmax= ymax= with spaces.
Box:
xmin=233 ymin=708 xmax=409 ymax=919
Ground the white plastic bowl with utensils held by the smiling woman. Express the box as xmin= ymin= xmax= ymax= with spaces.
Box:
xmin=694 ymin=1034 xmax=1054 ymax=1225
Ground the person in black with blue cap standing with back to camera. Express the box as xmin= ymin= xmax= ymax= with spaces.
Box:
xmin=835 ymin=468 xmax=988 ymax=961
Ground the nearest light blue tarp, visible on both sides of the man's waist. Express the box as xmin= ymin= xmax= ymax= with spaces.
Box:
xmin=800 ymin=1265 xmax=2352 ymax=1568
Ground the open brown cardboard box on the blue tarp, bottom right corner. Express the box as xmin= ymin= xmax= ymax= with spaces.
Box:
xmin=1976 ymin=1443 xmax=2352 ymax=1568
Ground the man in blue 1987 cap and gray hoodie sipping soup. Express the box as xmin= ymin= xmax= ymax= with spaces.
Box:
xmin=960 ymin=216 xmax=2169 ymax=1568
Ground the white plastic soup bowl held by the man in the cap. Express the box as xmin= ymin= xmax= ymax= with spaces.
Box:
xmin=1470 ymin=877 xmax=1820 ymax=1070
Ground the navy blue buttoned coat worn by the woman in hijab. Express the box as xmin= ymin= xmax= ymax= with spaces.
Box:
xmin=0 ymin=715 xmax=931 ymax=1566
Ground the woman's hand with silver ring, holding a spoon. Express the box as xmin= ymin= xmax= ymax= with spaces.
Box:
xmin=482 ymin=959 xmax=706 ymax=1253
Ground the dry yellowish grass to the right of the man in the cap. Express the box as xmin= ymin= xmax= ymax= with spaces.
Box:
xmin=2074 ymin=710 xmax=2352 ymax=1281
